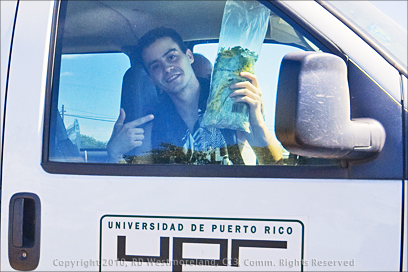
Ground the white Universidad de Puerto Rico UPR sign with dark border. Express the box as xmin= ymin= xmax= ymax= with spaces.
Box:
xmin=99 ymin=215 xmax=304 ymax=271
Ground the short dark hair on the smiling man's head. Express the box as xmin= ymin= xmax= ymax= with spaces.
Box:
xmin=136 ymin=27 xmax=187 ymax=70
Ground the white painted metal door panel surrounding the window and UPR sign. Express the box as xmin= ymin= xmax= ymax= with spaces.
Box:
xmin=1 ymin=1 xmax=402 ymax=271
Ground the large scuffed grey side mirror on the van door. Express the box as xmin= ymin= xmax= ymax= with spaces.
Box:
xmin=275 ymin=52 xmax=385 ymax=159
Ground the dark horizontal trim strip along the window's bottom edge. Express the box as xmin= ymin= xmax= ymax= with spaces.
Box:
xmin=42 ymin=162 xmax=348 ymax=179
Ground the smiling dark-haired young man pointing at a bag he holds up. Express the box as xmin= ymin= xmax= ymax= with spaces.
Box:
xmin=108 ymin=28 xmax=282 ymax=164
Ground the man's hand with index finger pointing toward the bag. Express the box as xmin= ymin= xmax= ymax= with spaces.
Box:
xmin=107 ymin=109 xmax=154 ymax=162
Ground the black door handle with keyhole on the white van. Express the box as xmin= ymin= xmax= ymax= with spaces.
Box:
xmin=8 ymin=193 xmax=41 ymax=271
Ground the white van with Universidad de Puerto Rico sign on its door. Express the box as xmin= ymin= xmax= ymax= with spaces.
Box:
xmin=1 ymin=1 xmax=408 ymax=271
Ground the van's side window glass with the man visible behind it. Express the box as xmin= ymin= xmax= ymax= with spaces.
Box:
xmin=46 ymin=1 xmax=338 ymax=172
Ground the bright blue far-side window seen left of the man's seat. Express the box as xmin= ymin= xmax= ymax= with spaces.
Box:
xmin=49 ymin=54 xmax=130 ymax=162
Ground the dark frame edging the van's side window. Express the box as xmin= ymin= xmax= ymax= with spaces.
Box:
xmin=41 ymin=1 xmax=348 ymax=179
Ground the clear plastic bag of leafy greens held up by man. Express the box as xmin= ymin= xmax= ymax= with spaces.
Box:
xmin=201 ymin=0 xmax=270 ymax=132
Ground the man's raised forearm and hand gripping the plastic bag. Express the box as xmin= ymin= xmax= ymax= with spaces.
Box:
xmin=230 ymin=72 xmax=283 ymax=164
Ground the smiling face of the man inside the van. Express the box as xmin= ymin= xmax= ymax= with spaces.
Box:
xmin=142 ymin=37 xmax=194 ymax=93
